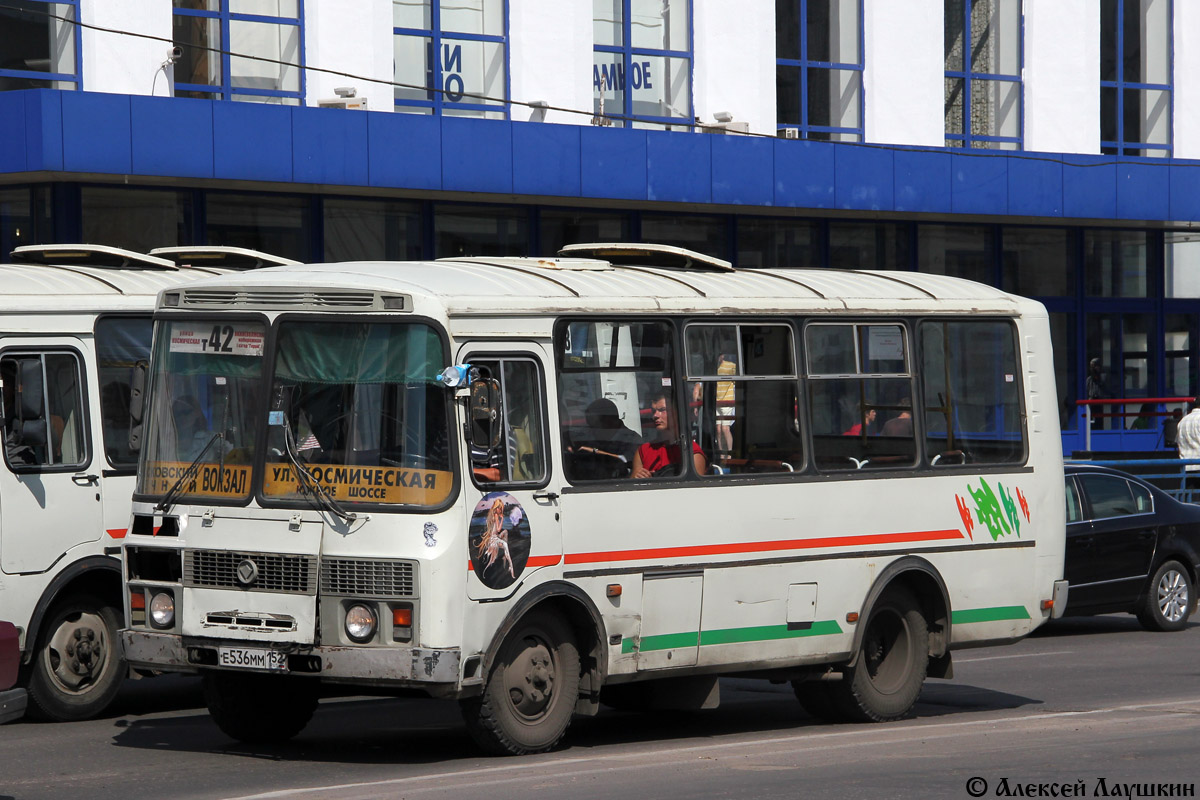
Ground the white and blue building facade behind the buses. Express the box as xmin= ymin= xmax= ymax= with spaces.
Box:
xmin=0 ymin=0 xmax=1200 ymax=451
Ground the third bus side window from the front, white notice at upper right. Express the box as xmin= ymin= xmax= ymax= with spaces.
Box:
xmin=804 ymin=323 xmax=917 ymax=470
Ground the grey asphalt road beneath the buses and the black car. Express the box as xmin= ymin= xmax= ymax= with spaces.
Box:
xmin=0 ymin=615 xmax=1200 ymax=800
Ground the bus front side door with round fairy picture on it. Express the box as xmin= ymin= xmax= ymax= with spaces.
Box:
xmin=457 ymin=342 xmax=563 ymax=600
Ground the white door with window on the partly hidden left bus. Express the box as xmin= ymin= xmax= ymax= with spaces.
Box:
xmin=0 ymin=345 xmax=103 ymax=575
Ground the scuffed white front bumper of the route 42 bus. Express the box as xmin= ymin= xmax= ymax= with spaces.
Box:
xmin=121 ymin=630 xmax=462 ymax=687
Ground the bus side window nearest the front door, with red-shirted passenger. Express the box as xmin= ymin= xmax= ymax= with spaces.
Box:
xmin=556 ymin=319 xmax=691 ymax=482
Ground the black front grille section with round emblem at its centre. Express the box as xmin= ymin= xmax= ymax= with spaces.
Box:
xmin=184 ymin=551 xmax=317 ymax=595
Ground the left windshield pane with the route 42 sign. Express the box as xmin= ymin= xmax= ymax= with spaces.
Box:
xmin=138 ymin=320 xmax=266 ymax=501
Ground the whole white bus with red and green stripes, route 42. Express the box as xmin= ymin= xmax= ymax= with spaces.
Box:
xmin=122 ymin=245 xmax=1066 ymax=753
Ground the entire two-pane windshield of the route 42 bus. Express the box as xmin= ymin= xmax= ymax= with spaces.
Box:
xmin=139 ymin=321 xmax=454 ymax=507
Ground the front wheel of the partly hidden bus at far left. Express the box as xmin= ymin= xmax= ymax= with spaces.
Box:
xmin=29 ymin=594 xmax=126 ymax=722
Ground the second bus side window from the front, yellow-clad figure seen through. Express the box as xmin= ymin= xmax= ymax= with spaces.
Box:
xmin=685 ymin=324 xmax=804 ymax=475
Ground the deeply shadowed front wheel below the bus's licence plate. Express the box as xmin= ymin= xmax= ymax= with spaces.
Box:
xmin=204 ymin=672 xmax=318 ymax=745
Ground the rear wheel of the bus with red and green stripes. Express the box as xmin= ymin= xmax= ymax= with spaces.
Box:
xmin=830 ymin=587 xmax=929 ymax=722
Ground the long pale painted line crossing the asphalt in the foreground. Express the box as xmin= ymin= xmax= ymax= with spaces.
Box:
xmin=229 ymin=698 xmax=1200 ymax=800
